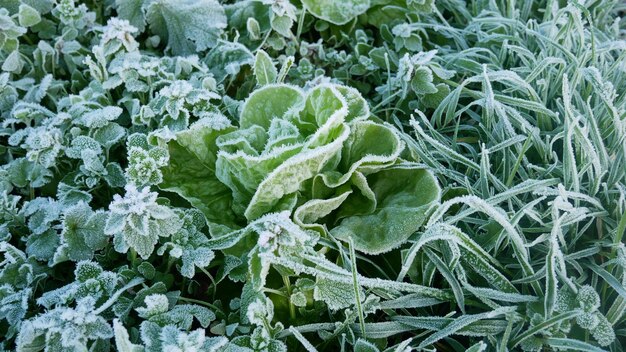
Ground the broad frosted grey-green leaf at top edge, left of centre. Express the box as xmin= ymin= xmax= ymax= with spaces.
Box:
xmin=146 ymin=0 xmax=226 ymax=55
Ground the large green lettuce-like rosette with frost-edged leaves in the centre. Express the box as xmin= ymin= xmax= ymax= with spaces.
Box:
xmin=160 ymin=84 xmax=440 ymax=254
